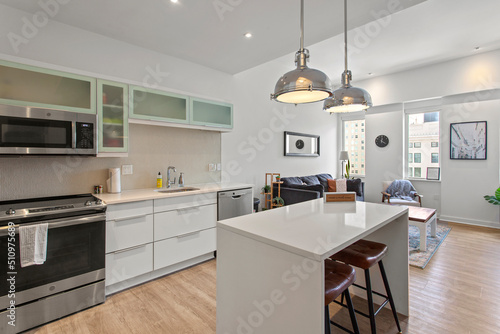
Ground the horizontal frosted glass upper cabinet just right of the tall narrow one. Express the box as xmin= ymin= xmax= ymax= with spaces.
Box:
xmin=129 ymin=86 xmax=189 ymax=123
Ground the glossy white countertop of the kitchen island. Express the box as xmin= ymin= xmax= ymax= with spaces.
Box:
xmin=217 ymin=198 xmax=408 ymax=260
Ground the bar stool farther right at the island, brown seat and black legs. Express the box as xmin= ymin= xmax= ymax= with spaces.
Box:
xmin=330 ymin=240 xmax=402 ymax=334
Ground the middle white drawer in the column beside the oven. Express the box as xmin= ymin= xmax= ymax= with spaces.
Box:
xmin=106 ymin=214 xmax=153 ymax=253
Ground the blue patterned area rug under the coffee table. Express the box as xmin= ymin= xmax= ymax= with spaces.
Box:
xmin=408 ymin=224 xmax=451 ymax=269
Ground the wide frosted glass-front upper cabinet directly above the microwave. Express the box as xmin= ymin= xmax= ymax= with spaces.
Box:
xmin=0 ymin=60 xmax=96 ymax=114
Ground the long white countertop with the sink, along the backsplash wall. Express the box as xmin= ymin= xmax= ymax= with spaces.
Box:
xmin=95 ymin=182 xmax=253 ymax=204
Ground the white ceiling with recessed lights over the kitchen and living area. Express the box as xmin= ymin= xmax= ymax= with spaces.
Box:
xmin=0 ymin=0 xmax=500 ymax=80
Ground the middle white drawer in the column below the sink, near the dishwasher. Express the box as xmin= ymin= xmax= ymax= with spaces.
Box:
xmin=154 ymin=204 xmax=217 ymax=241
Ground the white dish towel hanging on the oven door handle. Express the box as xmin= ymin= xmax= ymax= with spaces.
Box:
xmin=19 ymin=223 xmax=49 ymax=267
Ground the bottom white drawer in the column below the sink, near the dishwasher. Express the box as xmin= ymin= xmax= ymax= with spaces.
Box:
xmin=154 ymin=228 xmax=217 ymax=270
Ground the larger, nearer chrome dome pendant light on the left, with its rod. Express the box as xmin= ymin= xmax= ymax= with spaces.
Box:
xmin=271 ymin=0 xmax=332 ymax=104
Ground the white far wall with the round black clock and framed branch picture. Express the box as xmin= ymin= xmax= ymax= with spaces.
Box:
xmin=356 ymin=50 xmax=500 ymax=227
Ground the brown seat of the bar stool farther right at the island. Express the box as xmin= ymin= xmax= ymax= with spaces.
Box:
xmin=330 ymin=239 xmax=387 ymax=269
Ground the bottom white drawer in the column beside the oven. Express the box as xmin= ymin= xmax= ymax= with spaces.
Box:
xmin=106 ymin=243 xmax=153 ymax=285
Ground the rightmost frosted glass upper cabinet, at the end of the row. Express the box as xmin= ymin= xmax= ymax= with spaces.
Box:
xmin=190 ymin=97 xmax=233 ymax=128
